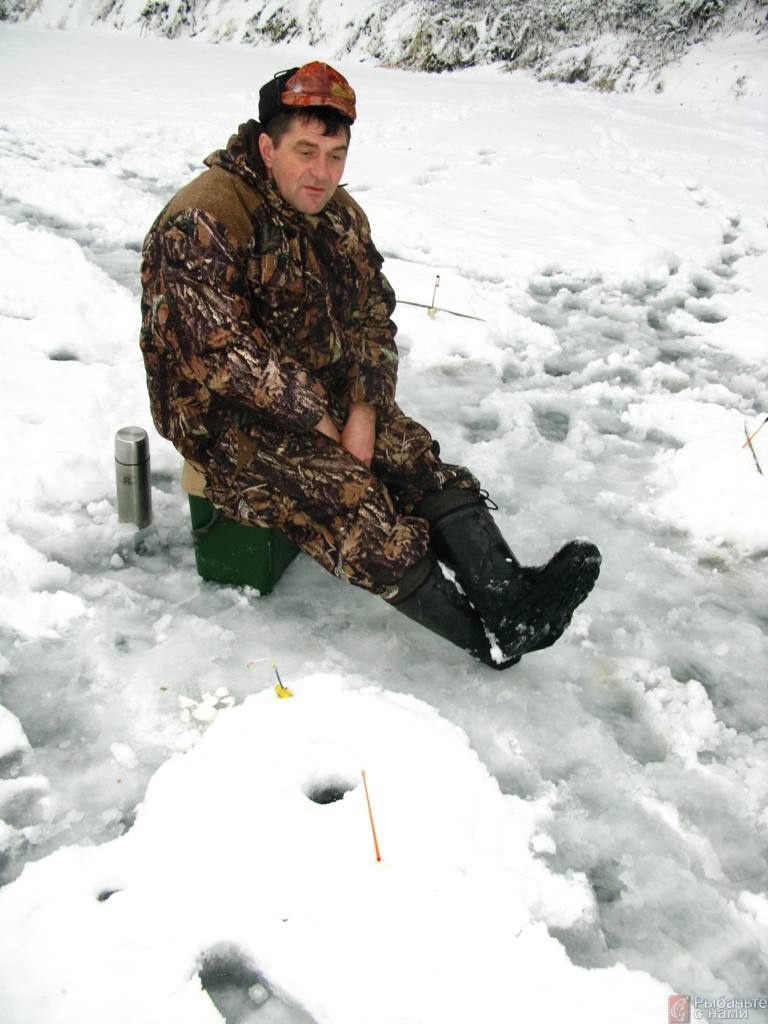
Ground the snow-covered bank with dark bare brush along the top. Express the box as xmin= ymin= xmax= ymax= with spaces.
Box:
xmin=0 ymin=0 xmax=768 ymax=92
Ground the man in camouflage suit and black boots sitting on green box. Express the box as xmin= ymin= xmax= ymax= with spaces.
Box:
xmin=141 ymin=61 xmax=600 ymax=668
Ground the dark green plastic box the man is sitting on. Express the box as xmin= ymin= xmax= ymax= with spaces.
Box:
xmin=188 ymin=495 xmax=299 ymax=594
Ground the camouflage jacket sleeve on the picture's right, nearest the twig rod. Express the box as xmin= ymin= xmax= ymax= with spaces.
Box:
xmin=339 ymin=207 xmax=398 ymax=409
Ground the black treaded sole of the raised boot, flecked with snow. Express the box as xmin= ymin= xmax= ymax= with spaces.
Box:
xmin=496 ymin=541 xmax=601 ymax=659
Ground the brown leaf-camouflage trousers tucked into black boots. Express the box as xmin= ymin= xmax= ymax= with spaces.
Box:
xmin=195 ymin=406 xmax=479 ymax=597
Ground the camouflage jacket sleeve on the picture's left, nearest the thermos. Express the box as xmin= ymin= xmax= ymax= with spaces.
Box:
xmin=153 ymin=210 xmax=326 ymax=431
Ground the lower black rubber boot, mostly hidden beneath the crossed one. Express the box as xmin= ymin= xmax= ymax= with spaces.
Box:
xmin=388 ymin=553 xmax=519 ymax=669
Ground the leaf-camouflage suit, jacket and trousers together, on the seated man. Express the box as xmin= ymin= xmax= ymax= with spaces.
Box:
xmin=141 ymin=121 xmax=478 ymax=597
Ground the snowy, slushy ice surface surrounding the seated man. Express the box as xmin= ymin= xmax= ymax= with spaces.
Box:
xmin=0 ymin=27 xmax=768 ymax=1024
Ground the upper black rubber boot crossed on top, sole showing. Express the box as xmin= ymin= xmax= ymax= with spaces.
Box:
xmin=415 ymin=489 xmax=600 ymax=658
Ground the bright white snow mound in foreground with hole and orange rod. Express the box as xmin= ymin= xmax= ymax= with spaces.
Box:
xmin=0 ymin=674 xmax=666 ymax=1024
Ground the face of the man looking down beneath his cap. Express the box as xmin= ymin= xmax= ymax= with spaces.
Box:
xmin=259 ymin=118 xmax=348 ymax=213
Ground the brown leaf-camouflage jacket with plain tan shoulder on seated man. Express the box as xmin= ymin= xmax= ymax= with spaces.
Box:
xmin=140 ymin=121 xmax=397 ymax=457
